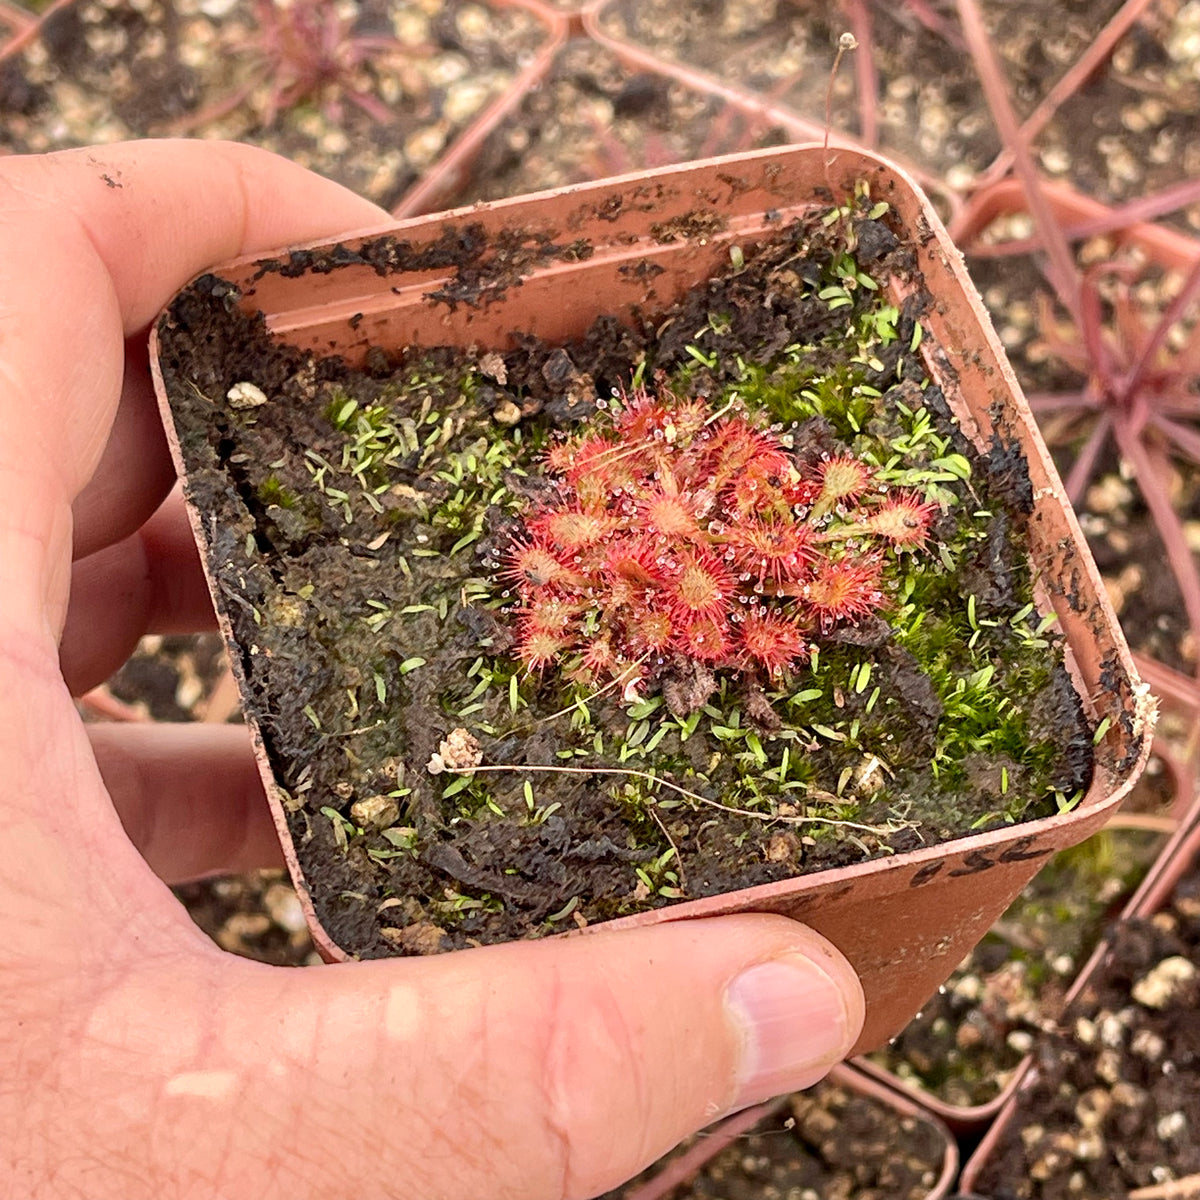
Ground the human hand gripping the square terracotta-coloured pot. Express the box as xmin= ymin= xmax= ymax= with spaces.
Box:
xmin=0 ymin=142 xmax=863 ymax=1200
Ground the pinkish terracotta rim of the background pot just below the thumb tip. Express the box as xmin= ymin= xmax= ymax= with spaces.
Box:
xmin=609 ymin=1066 xmax=959 ymax=1200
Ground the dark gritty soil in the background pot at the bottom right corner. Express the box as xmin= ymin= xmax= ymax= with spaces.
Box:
xmin=976 ymin=874 xmax=1200 ymax=1200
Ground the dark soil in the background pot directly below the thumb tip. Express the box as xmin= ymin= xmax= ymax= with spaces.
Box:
xmin=604 ymin=1081 xmax=947 ymax=1200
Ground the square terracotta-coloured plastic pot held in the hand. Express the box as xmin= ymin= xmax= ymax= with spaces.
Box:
xmin=151 ymin=148 xmax=1153 ymax=1052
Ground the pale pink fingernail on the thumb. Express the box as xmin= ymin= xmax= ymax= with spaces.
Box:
xmin=725 ymin=954 xmax=852 ymax=1109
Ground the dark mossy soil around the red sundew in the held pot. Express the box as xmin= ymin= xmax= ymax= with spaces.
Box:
xmin=160 ymin=202 xmax=1092 ymax=956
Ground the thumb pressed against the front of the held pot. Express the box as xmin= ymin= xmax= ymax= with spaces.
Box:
xmin=248 ymin=916 xmax=864 ymax=1200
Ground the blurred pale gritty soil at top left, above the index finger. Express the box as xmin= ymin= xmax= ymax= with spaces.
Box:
xmin=0 ymin=0 xmax=550 ymax=208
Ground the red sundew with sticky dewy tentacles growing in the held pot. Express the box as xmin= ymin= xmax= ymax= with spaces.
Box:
xmin=503 ymin=388 xmax=936 ymax=701
